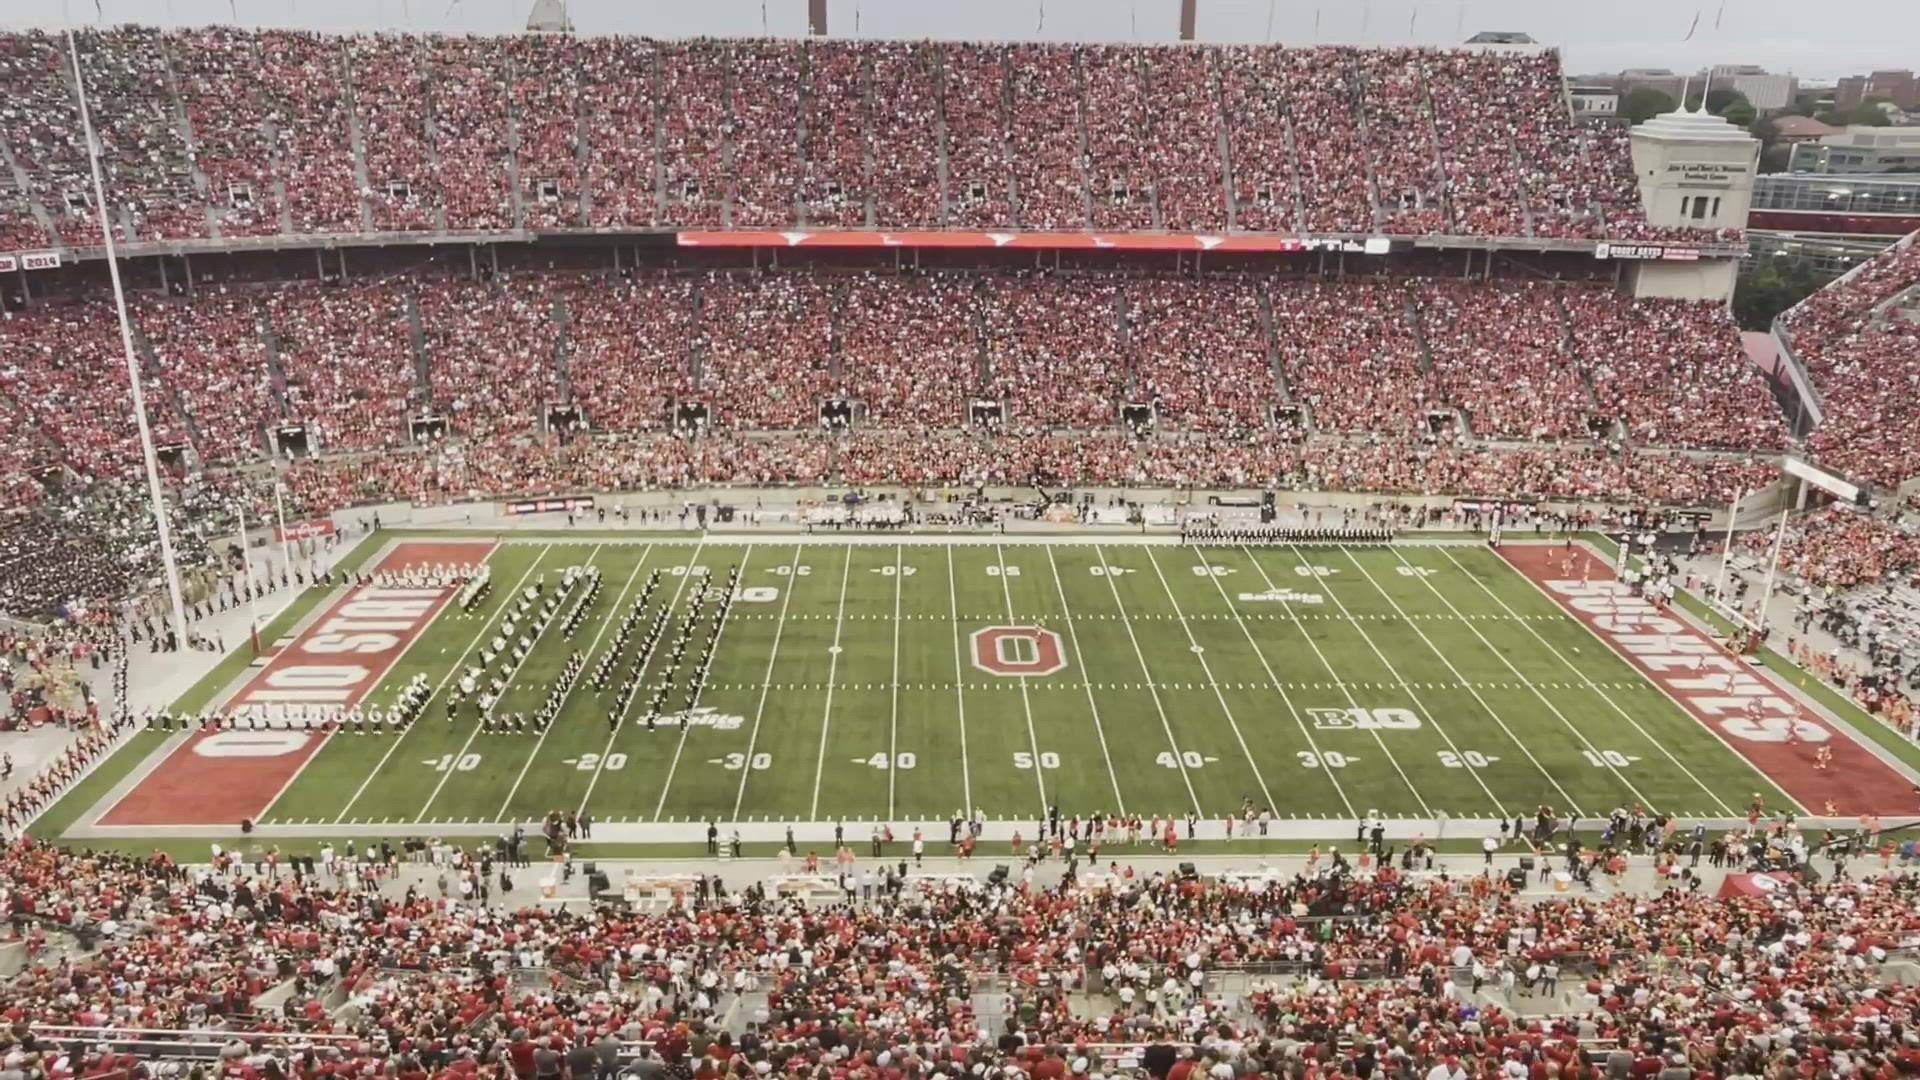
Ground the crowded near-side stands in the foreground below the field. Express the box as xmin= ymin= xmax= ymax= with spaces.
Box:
xmin=0 ymin=840 xmax=1920 ymax=1080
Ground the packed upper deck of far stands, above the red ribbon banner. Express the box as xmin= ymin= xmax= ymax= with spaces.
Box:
xmin=0 ymin=27 xmax=1697 ymax=246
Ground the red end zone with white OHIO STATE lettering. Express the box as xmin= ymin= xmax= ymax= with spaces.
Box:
xmin=98 ymin=540 xmax=493 ymax=824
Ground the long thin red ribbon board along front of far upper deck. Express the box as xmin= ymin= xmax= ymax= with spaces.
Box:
xmin=678 ymin=229 xmax=1413 ymax=256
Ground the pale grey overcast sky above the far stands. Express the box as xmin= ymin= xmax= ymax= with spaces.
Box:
xmin=0 ymin=0 xmax=1920 ymax=79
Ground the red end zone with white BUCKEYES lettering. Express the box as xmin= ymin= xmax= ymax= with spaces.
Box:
xmin=1500 ymin=544 xmax=1920 ymax=817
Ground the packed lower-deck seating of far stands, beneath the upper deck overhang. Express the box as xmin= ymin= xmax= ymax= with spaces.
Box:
xmin=0 ymin=271 xmax=1786 ymax=502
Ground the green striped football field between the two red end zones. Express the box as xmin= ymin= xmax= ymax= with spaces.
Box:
xmin=236 ymin=536 xmax=1789 ymax=836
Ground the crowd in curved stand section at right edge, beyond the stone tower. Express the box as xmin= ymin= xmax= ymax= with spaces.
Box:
xmin=1782 ymin=244 xmax=1920 ymax=488
